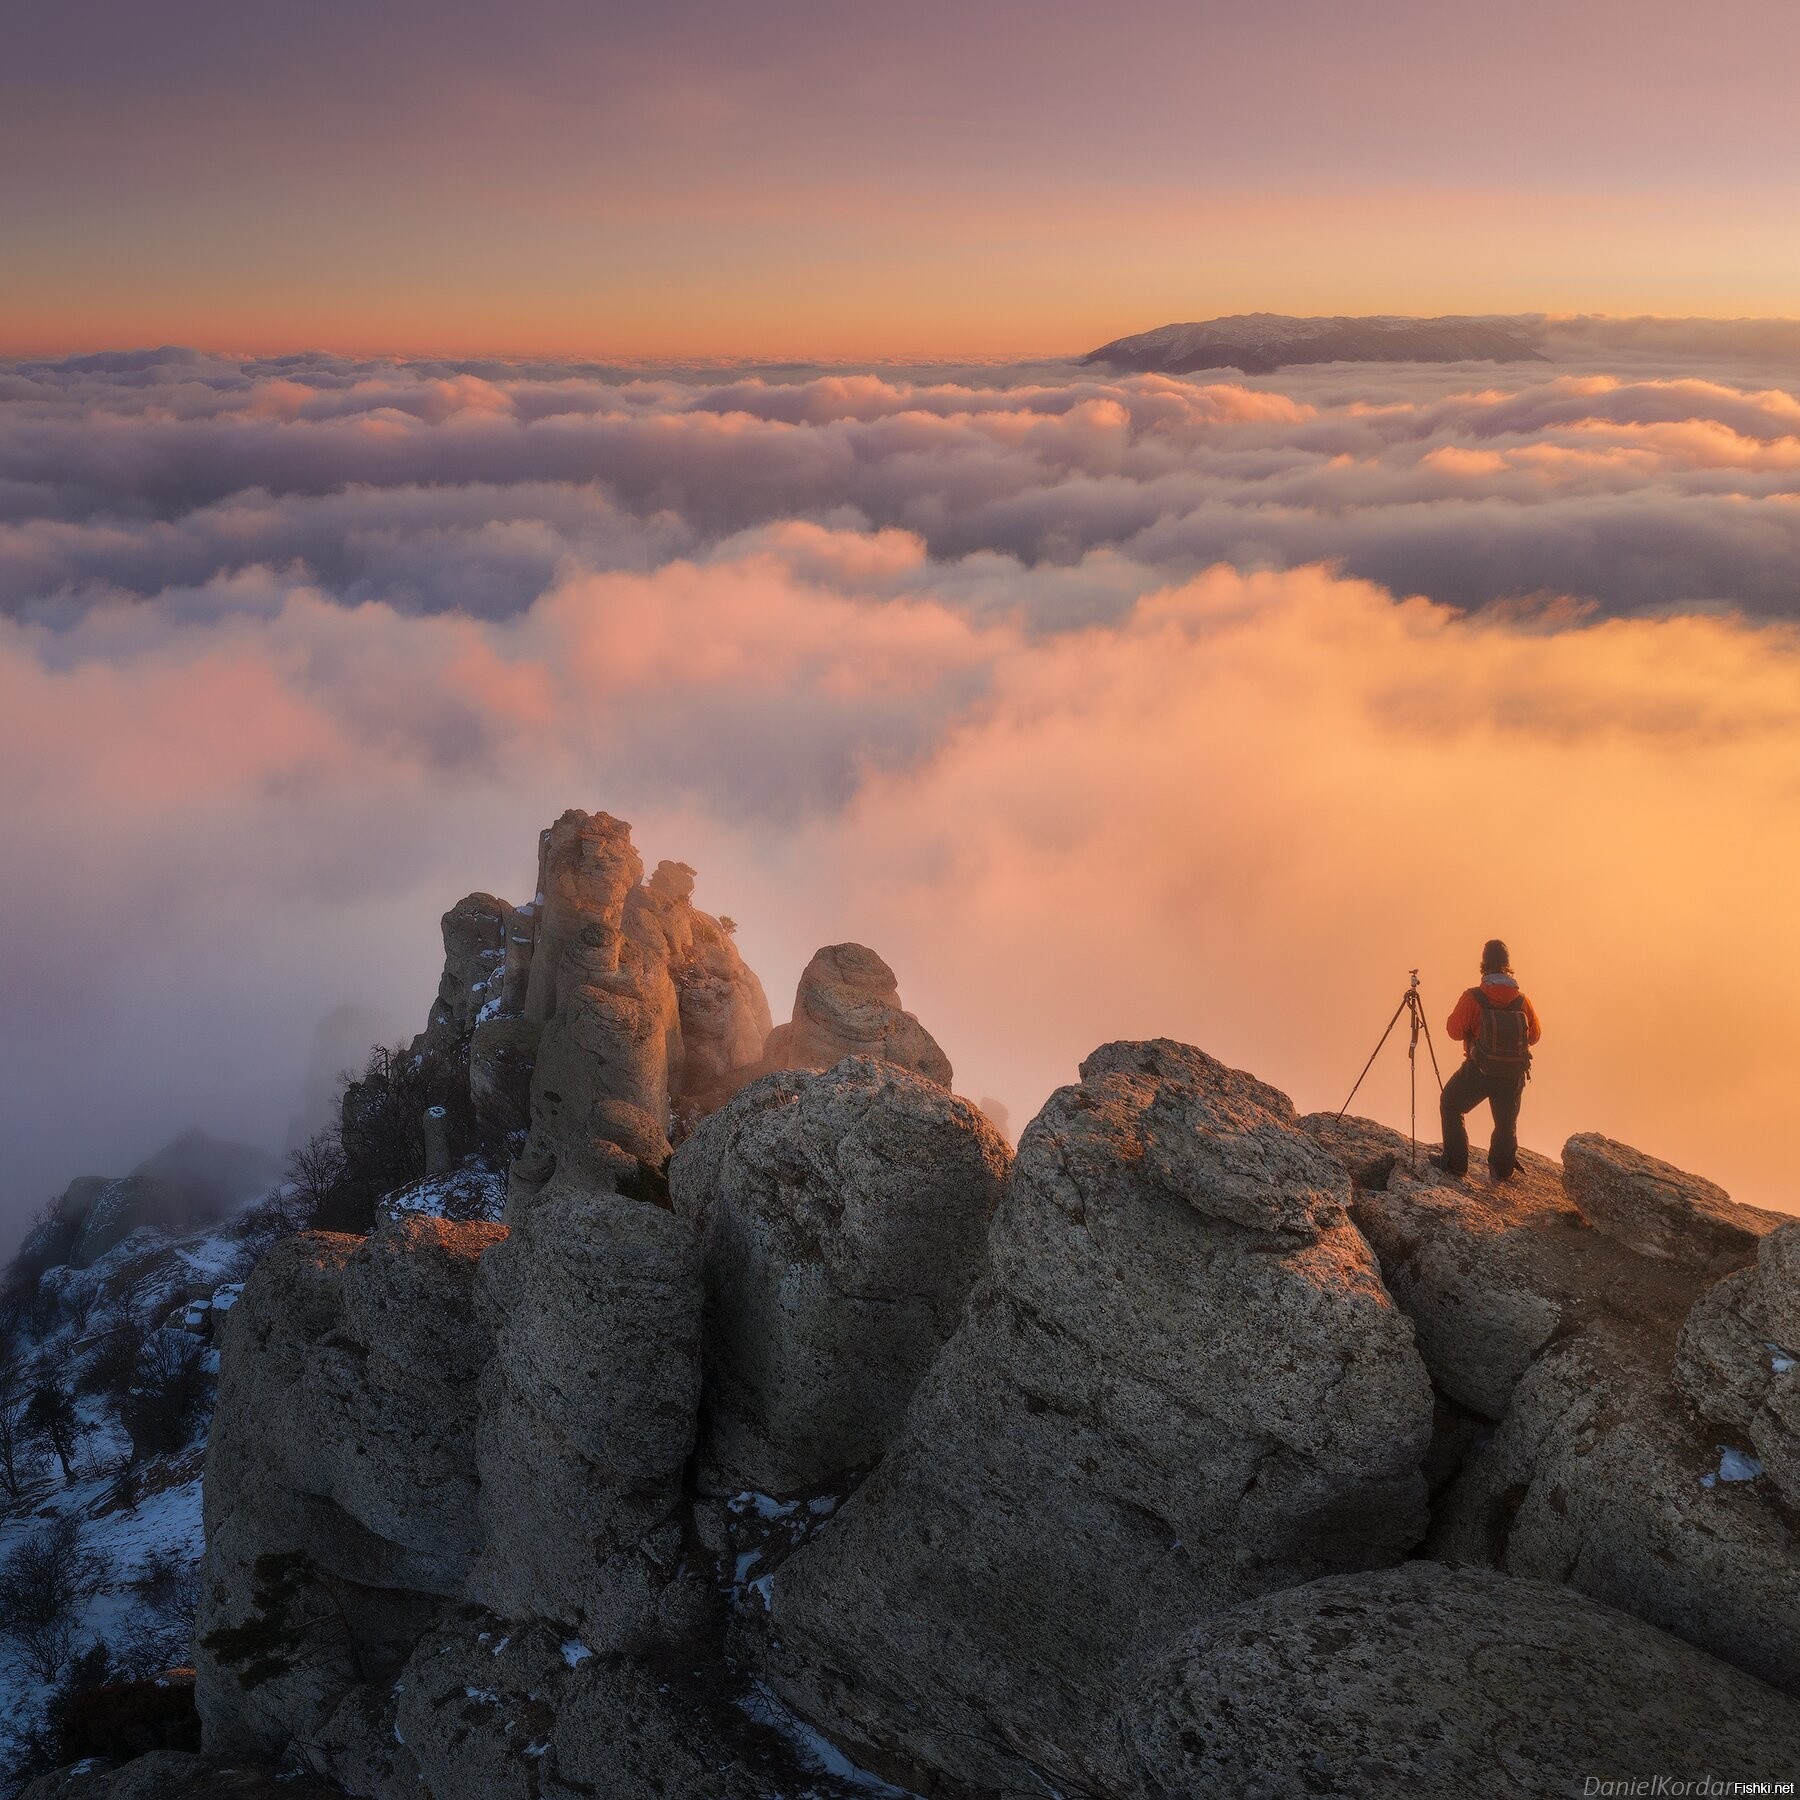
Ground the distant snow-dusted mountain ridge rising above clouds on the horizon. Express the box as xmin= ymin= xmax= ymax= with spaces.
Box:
xmin=1082 ymin=313 xmax=1550 ymax=374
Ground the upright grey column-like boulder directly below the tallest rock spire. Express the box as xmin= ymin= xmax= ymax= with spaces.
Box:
xmin=466 ymin=1184 xmax=700 ymax=1651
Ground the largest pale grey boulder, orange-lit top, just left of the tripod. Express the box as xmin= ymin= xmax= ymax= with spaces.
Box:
xmin=763 ymin=1040 xmax=1431 ymax=1793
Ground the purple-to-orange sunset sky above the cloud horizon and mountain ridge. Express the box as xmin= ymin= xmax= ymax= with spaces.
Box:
xmin=10 ymin=0 xmax=1800 ymax=360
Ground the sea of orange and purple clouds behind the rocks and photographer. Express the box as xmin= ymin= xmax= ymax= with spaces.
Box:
xmin=0 ymin=328 xmax=1800 ymax=1242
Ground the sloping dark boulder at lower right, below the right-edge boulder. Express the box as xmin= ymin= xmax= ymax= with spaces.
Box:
xmin=1429 ymin=1319 xmax=1800 ymax=1694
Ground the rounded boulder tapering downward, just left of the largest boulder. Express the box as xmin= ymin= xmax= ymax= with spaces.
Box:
xmin=670 ymin=1058 xmax=1010 ymax=1494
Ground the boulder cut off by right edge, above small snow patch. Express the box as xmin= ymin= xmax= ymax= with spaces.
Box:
xmin=1676 ymin=1220 xmax=1800 ymax=1512
